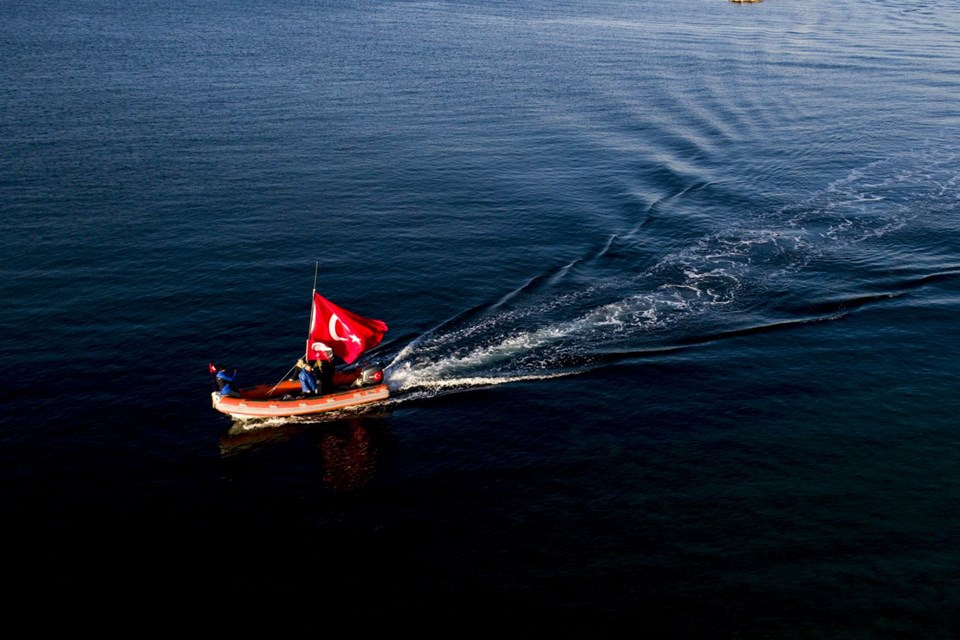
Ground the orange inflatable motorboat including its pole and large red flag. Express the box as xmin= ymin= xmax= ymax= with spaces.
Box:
xmin=209 ymin=263 xmax=390 ymax=420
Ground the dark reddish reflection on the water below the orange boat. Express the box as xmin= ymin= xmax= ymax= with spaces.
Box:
xmin=220 ymin=413 xmax=391 ymax=493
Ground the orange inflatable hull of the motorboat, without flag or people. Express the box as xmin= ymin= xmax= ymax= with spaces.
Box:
xmin=211 ymin=380 xmax=390 ymax=419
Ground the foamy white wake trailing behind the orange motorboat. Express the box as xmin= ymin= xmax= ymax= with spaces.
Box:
xmin=384 ymin=149 xmax=960 ymax=401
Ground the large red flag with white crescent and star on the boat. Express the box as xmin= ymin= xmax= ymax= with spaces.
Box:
xmin=307 ymin=291 xmax=387 ymax=364
